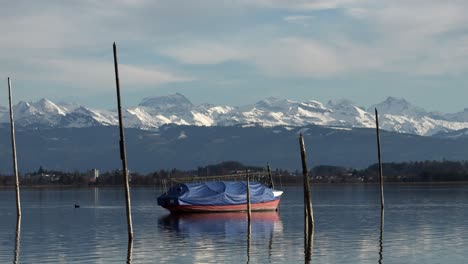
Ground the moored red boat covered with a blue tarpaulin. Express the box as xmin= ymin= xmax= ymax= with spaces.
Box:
xmin=158 ymin=181 xmax=283 ymax=213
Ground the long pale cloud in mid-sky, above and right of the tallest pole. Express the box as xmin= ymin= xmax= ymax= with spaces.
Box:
xmin=159 ymin=37 xmax=357 ymax=77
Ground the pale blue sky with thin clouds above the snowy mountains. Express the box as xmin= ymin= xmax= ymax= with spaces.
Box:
xmin=0 ymin=0 xmax=468 ymax=112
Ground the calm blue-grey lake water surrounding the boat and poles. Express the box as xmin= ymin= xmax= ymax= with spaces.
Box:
xmin=0 ymin=185 xmax=468 ymax=263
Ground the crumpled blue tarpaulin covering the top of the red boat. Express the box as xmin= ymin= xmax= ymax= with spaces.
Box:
xmin=158 ymin=181 xmax=277 ymax=206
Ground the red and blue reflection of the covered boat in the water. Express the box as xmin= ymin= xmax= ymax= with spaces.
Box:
xmin=159 ymin=211 xmax=283 ymax=238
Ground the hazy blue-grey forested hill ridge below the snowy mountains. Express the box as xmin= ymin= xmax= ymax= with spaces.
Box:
xmin=0 ymin=125 xmax=468 ymax=172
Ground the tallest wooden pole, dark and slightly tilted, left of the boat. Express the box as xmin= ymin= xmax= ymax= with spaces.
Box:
xmin=113 ymin=42 xmax=133 ymax=240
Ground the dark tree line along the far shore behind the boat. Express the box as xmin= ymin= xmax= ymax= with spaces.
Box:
xmin=0 ymin=160 xmax=468 ymax=186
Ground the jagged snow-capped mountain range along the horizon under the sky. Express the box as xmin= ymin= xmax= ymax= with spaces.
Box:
xmin=0 ymin=93 xmax=468 ymax=136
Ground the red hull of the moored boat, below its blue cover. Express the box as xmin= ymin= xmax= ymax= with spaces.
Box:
xmin=163 ymin=199 xmax=280 ymax=213
